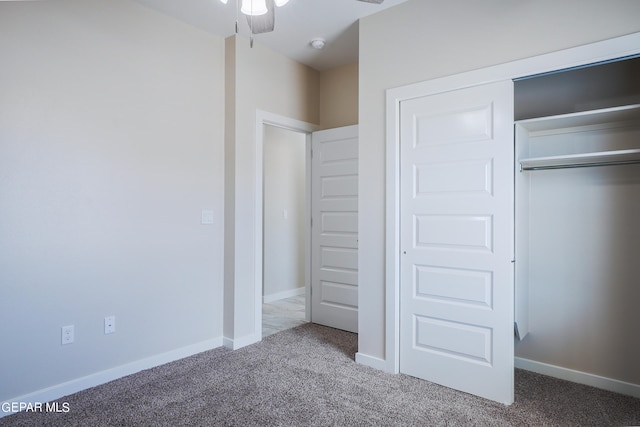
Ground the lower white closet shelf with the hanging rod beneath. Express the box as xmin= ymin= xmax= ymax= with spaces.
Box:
xmin=520 ymin=149 xmax=640 ymax=171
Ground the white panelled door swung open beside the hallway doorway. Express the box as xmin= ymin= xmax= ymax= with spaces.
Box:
xmin=311 ymin=126 xmax=358 ymax=332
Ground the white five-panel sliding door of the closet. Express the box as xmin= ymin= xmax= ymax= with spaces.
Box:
xmin=400 ymin=81 xmax=514 ymax=404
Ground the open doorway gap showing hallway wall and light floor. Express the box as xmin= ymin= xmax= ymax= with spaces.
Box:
xmin=262 ymin=125 xmax=308 ymax=338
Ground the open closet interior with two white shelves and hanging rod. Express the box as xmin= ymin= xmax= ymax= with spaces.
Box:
xmin=514 ymin=58 xmax=640 ymax=384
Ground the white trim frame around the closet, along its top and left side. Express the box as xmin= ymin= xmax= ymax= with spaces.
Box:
xmin=385 ymin=33 xmax=640 ymax=373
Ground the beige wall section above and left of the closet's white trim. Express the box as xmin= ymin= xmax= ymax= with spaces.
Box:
xmin=358 ymin=0 xmax=640 ymax=360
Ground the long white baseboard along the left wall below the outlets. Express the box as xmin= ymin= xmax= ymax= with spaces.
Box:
xmin=0 ymin=338 xmax=223 ymax=418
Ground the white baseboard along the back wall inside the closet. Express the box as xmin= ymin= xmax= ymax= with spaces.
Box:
xmin=515 ymin=357 xmax=640 ymax=398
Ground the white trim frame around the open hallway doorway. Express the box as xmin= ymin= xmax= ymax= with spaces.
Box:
xmin=252 ymin=110 xmax=320 ymax=341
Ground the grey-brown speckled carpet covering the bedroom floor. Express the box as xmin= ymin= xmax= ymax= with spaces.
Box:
xmin=5 ymin=324 xmax=640 ymax=426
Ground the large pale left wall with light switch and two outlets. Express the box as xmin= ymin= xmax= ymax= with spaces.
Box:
xmin=0 ymin=0 xmax=224 ymax=400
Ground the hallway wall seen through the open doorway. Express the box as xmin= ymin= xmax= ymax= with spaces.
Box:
xmin=263 ymin=126 xmax=307 ymax=301
